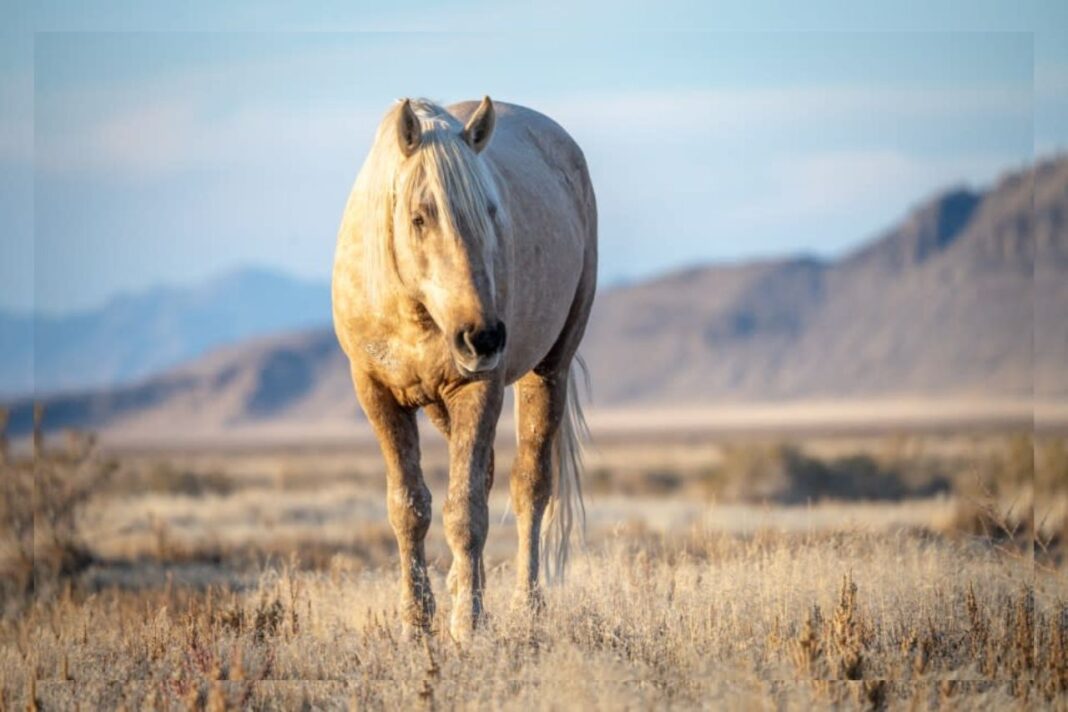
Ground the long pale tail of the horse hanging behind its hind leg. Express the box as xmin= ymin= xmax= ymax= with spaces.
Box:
xmin=541 ymin=354 xmax=590 ymax=582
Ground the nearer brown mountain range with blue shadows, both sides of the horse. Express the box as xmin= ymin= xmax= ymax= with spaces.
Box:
xmin=4 ymin=158 xmax=1068 ymax=439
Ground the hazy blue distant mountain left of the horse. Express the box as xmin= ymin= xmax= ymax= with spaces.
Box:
xmin=0 ymin=268 xmax=330 ymax=394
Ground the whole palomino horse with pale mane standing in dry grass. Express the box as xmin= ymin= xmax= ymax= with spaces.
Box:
xmin=333 ymin=97 xmax=597 ymax=639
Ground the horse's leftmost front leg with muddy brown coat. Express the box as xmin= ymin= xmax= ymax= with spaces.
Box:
xmin=354 ymin=375 xmax=434 ymax=631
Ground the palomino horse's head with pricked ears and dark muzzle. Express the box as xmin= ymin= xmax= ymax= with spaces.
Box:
xmin=392 ymin=96 xmax=506 ymax=375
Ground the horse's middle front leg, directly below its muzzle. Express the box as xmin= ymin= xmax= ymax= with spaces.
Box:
xmin=444 ymin=380 xmax=503 ymax=640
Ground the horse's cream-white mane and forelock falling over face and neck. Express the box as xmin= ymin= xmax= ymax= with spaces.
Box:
xmin=350 ymin=99 xmax=499 ymax=305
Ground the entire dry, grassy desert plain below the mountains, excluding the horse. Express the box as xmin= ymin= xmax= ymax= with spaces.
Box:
xmin=0 ymin=414 xmax=1068 ymax=710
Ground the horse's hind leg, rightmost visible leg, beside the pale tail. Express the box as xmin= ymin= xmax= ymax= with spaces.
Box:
xmin=511 ymin=371 xmax=567 ymax=608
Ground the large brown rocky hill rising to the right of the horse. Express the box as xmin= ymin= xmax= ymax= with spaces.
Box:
xmin=584 ymin=159 xmax=1068 ymax=402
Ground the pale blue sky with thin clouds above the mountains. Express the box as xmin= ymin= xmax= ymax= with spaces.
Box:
xmin=0 ymin=0 xmax=1068 ymax=313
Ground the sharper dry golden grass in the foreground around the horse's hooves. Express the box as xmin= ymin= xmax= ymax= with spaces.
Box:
xmin=0 ymin=529 xmax=1068 ymax=709
